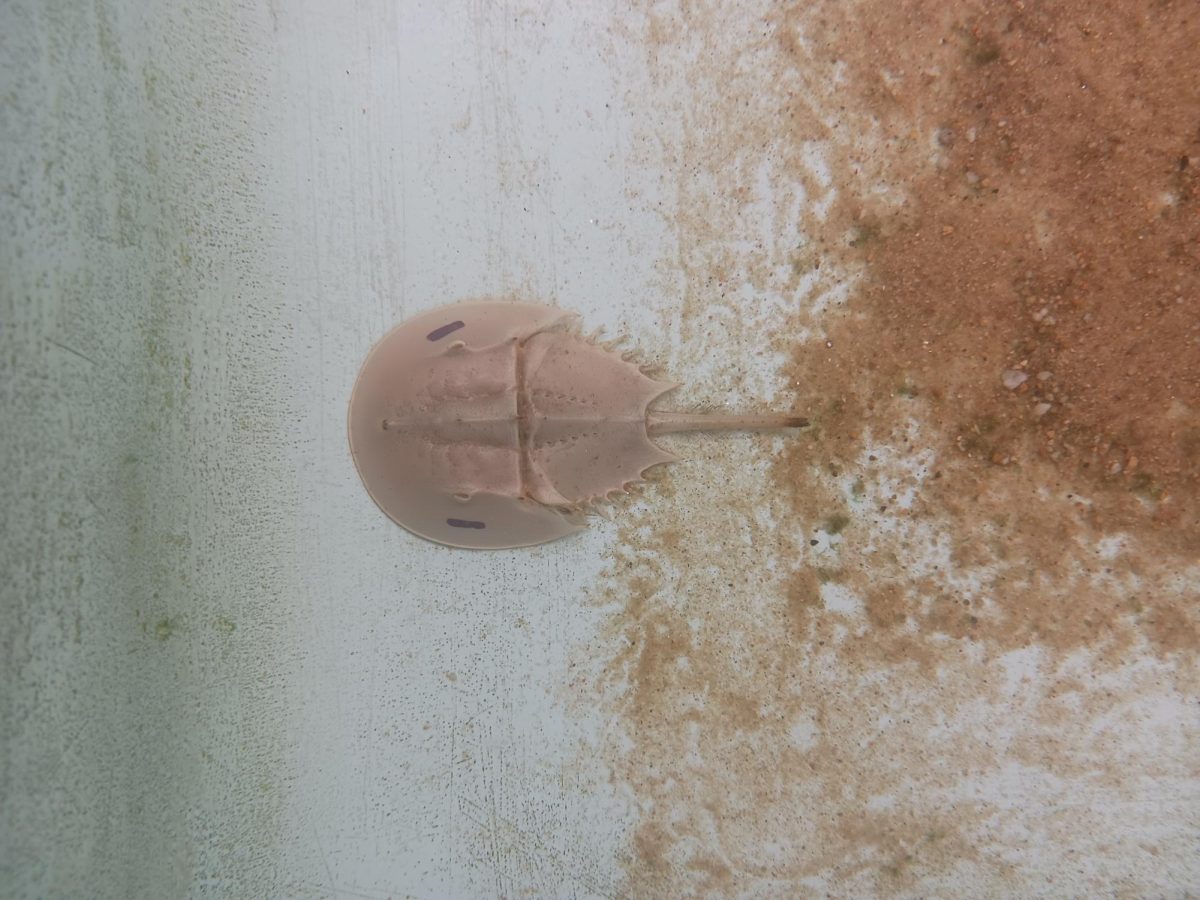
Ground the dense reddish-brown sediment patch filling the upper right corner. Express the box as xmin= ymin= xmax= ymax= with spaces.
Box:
xmin=779 ymin=2 xmax=1200 ymax=557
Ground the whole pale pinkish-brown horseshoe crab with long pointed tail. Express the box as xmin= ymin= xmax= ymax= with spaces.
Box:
xmin=349 ymin=300 xmax=808 ymax=548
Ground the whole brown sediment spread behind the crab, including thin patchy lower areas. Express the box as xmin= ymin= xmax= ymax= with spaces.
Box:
xmin=578 ymin=0 xmax=1200 ymax=896
